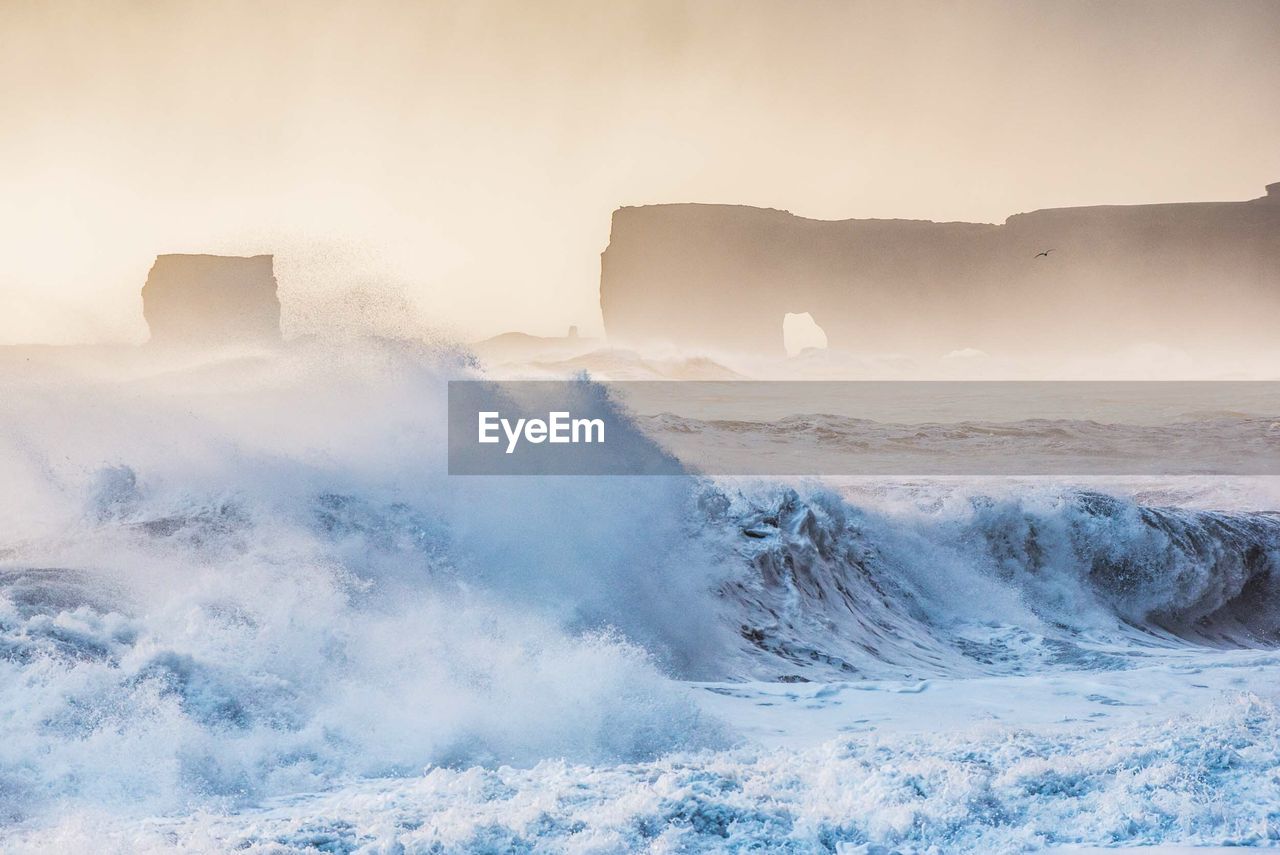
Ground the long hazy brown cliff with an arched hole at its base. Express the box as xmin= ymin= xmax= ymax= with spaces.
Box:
xmin=600 ymin=184 xmax=1280 ymax=353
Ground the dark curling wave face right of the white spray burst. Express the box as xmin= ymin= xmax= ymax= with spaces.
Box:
xmin=717 ymin=490 xmax=1280 ymax=676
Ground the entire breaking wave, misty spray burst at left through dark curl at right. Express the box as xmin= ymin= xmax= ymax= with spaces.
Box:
xmin=0 ymin=342 xmax=1280 ymax=823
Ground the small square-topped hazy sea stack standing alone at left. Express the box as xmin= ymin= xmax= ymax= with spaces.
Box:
xmin=142 ymin=255 xmax=280 ymax=347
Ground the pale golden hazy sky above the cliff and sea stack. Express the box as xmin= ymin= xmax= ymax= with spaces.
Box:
xmin=0 ymin=0 xmax=1280 ymax=342
